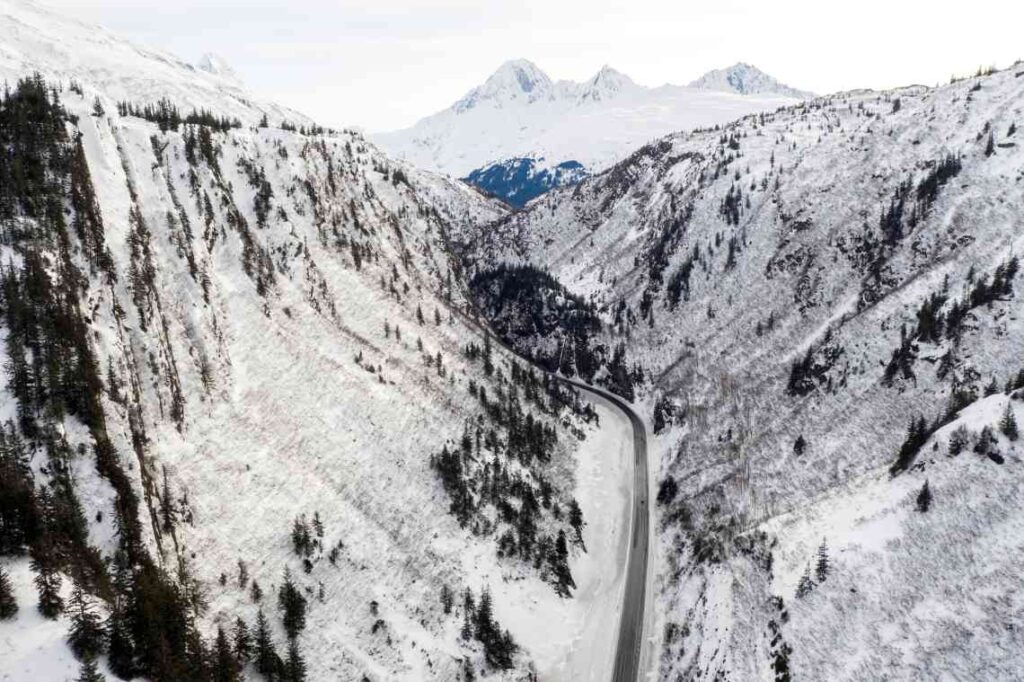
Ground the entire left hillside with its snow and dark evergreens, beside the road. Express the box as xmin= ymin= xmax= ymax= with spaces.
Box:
xmin=0 ymin=1 xmax=623 ymax=681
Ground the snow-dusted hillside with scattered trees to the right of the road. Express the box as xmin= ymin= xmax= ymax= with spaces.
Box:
xmin=458 ymin=63 xmax=1024 ymax=680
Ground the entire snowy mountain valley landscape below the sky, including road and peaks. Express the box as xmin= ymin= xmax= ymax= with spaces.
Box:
xmin=0 ymin=0 xmax=1024 ymax=682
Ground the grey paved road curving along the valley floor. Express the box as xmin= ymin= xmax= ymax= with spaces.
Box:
xmin=551 ymin=374 xmax=650 ymax=682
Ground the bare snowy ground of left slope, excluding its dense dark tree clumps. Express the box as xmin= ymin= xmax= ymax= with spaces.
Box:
xmin=0 ymin=1 xmax=622 ymax=681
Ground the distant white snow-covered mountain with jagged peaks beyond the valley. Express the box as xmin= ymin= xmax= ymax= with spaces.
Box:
xmin=372 ymin=59 xmax=794 ymax=177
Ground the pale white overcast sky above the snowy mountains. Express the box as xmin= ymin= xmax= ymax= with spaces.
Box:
xmin=42 ymin=0 xmax=1024 ymax=131
